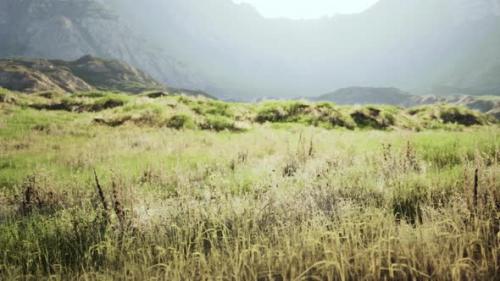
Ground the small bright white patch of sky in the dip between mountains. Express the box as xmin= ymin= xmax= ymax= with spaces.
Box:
xmin=233 ymin=0 xmax=378 ymax=18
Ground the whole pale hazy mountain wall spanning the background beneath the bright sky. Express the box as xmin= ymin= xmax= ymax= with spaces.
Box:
xmin=0 ymin=0 xmax=500 ymax=100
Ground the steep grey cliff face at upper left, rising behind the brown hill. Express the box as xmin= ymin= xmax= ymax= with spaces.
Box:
xmin=0 ymin=0 xmax=207 ymax=92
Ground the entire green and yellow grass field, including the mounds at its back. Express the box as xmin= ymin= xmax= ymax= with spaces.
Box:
xmin=0 ymin=91 xmax=500 ymax=281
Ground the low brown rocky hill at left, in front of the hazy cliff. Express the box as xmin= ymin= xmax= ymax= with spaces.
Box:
xmin=0 ymin=56 xmax=165 ymax=93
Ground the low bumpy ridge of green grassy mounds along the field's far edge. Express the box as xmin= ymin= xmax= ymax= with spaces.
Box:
xmin=0 ymin=90 xmax=497 ymax=132
